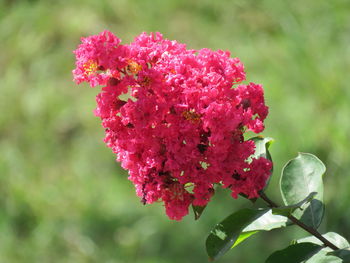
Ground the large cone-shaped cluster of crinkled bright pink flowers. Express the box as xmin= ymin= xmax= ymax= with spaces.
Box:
xmin=73 ymin=31 xmax=272 ymax=220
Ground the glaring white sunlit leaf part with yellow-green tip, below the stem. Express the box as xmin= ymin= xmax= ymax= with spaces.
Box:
xmin=232 ymin=209 xmax=288 ymax=248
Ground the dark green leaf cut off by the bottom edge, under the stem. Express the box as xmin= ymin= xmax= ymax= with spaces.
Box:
xmin=265 ymin=243 xmax=322 ymax=263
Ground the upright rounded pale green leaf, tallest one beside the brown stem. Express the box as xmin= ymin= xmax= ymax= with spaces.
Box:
xmin=280 ymin=153 xmax=326 ymax=229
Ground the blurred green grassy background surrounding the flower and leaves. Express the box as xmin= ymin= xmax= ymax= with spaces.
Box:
xmin=0 ymin=0 xmax=350 ymax=263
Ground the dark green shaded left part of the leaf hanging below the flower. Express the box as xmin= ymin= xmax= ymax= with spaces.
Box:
xmin=206 ymin=208 xmax=268 ymax=260
